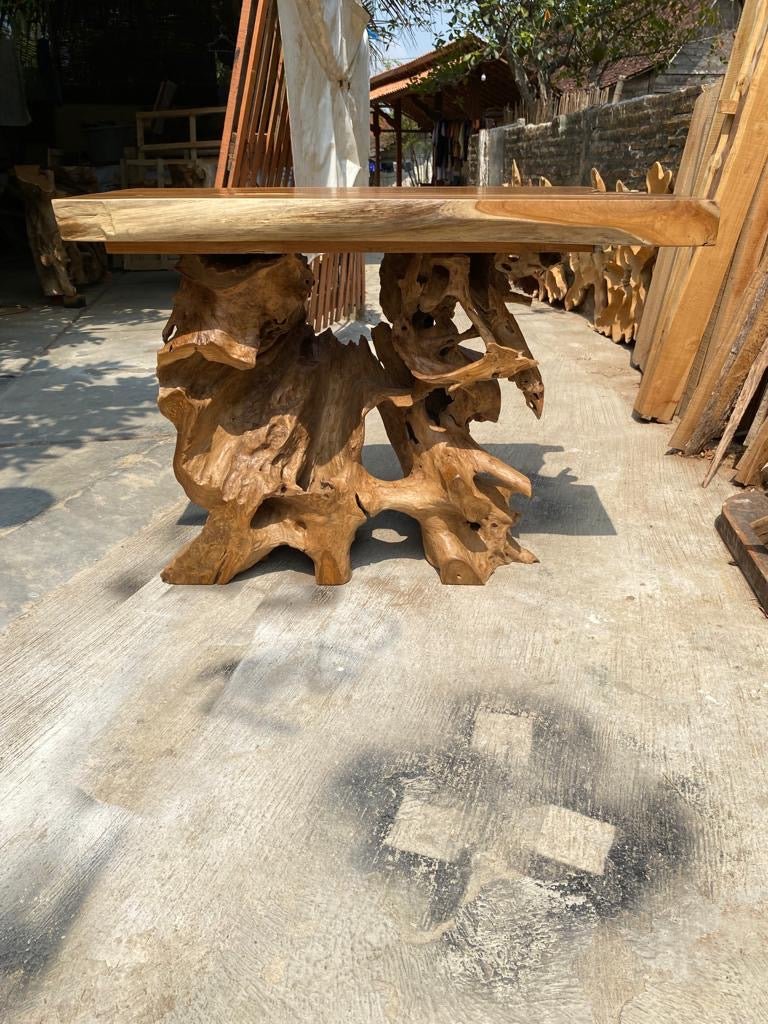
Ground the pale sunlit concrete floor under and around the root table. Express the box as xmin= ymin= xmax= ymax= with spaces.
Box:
xmin=0 ymin=266 xmax=768 ymax=1024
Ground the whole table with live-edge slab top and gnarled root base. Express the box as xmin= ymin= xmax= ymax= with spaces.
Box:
xmin=53 ymin=188 xmax=718 ymax=584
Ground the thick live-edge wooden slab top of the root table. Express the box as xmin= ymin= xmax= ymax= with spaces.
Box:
xmin=53 ymin=187 xmax=719 ymax=254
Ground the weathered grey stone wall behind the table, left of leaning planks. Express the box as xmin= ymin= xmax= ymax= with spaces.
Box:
xmin=470 ymin=86 xmax=700 ymax=190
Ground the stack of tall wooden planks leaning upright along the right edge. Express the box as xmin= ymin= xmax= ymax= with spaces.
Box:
xmin=634 ymin=0 xmax=768 ymax=483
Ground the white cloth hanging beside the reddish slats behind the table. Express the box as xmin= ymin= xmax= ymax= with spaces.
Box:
xmin=278 ymin=0 xmax=370 ymax=185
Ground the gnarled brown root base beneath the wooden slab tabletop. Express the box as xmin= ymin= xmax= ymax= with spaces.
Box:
xmin=158 ymin=254 xmax=544 ymax=584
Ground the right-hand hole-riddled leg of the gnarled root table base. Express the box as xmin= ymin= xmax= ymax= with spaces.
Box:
xmin=373 ymin=254 xmax=544 ymax=584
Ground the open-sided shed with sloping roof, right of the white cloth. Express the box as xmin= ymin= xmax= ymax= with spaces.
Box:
xmin=371 ymin=40 xmax=520 ymax=185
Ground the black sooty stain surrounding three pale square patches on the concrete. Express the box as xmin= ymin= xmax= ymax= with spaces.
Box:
xmin=332 ymin=694 xmax=694 ymax=954
